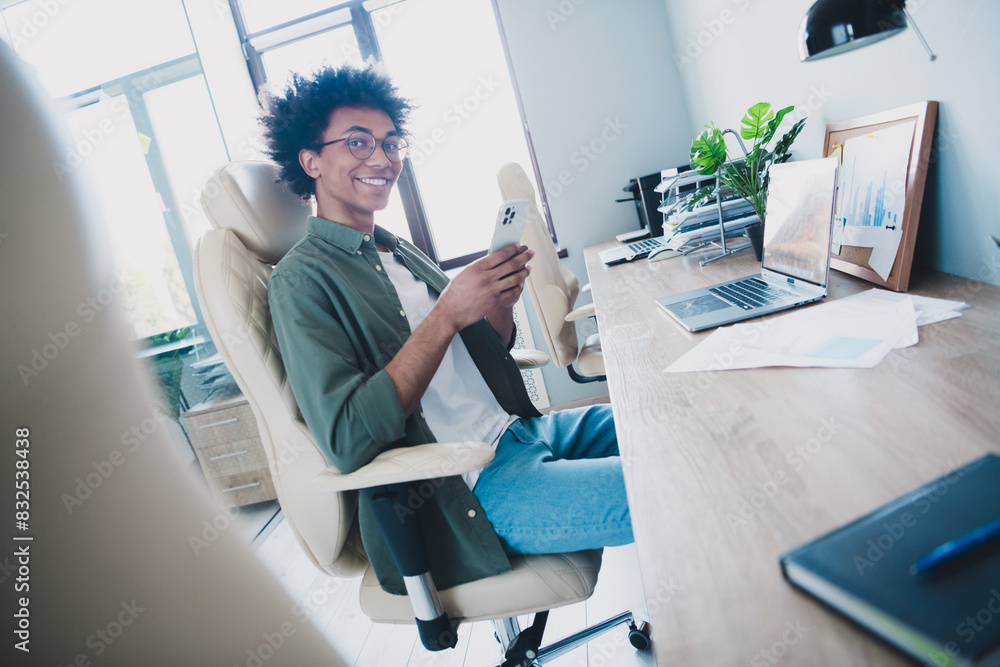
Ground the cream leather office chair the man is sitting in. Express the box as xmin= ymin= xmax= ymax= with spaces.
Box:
xmin=194 ymin=161 xmax=649 ymax=665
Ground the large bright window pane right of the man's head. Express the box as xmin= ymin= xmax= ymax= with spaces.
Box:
xmin=372 ymin=0 xmax=531 ymax=264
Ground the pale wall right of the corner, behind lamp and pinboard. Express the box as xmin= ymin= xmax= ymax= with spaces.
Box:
xmin=663 ymin=0 xmax=1000 ymax=284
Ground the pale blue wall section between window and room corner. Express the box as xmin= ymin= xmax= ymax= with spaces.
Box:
xmin=498 ymin=0 xmax=692 ymax=404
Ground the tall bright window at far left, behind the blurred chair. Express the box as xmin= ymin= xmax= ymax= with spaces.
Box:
xmin=3 ymin=0 xmax=228 ymax=338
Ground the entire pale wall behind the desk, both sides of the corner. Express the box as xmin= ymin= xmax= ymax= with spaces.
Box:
xmin=498 ymin=0 xmax=1000 ymax=403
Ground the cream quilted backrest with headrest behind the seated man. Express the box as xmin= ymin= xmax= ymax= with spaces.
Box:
xmin=194 ymin=161 xmax=367 ymax=576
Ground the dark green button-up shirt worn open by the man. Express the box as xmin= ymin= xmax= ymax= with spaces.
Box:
xmin=268 ymin=216 xmax=538 ymax=595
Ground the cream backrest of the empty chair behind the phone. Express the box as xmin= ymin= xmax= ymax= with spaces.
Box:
xmin=497 ymin=162 xmax=580 ymax=368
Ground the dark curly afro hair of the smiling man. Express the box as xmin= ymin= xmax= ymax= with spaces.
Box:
xmin=259 ymin=64 xmax=413 ymax=200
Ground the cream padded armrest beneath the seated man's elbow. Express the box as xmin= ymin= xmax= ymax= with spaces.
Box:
xmin=313 ymin=442 xmax=493 ymax=491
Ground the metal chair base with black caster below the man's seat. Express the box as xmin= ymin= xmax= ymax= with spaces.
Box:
xmin=493 ymin=611 xmax=651 ymax=667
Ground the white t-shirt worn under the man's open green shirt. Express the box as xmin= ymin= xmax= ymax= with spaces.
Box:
xmin=379 ymin=252 xmax=517 ymax=489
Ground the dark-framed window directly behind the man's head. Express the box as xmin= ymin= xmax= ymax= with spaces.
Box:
xmin=232 ymin=0 xmax=556 ymax=269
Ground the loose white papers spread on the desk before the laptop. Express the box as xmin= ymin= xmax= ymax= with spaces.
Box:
xmin=665 ymin=289 xmax=967 ymax=373
